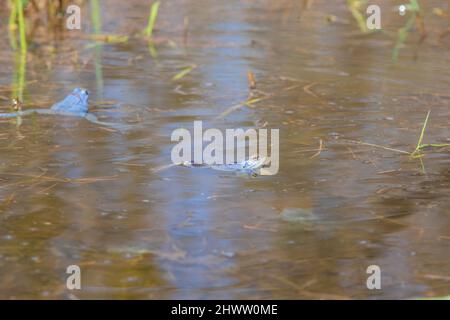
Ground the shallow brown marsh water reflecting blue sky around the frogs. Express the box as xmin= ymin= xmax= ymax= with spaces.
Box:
xmin=0 ymin=0 xmax=450 ymax=299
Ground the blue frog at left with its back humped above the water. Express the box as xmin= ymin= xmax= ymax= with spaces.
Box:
xmin=0 ymin=88 xmax=125 ymax=129
